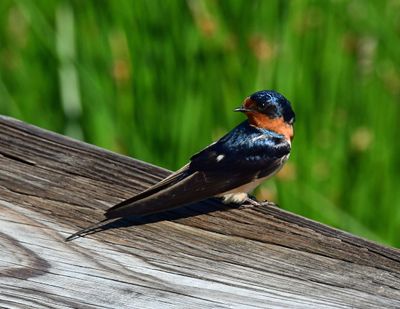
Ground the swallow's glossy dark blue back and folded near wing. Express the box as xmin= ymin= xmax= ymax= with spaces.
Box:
xmin=105 ymin=122 xmax=290 ymax=219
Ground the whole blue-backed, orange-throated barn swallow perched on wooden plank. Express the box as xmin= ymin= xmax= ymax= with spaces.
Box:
xmin=66 ymin=90 xmax=295 ymax=240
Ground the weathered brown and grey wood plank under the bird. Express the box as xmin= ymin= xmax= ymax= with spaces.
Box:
xmin=0 ymin=117 xmax=400 ymax=308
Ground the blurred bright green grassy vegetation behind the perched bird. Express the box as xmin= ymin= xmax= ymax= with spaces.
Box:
xmin=0 ymin=0 xmax=400 ymax=246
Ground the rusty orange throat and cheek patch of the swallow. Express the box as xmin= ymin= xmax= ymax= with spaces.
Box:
xmin=246 ymin=112 xmax=294 ymax=141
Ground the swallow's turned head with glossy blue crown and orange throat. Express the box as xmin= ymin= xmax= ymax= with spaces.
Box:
xmin=235 ymin=90 xmax=295 ymax=140
